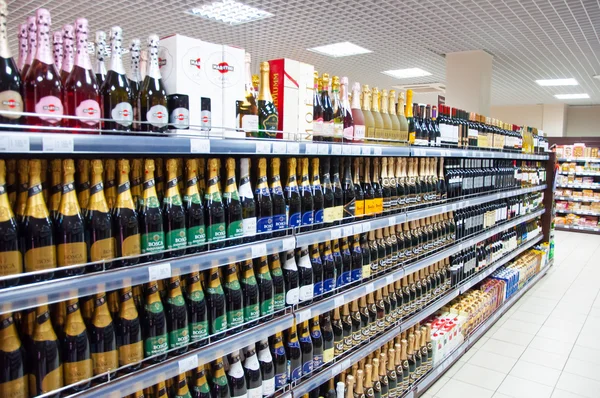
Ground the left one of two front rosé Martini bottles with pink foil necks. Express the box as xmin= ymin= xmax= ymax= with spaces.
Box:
xmin=23 ymin=8 xmax=64 ymax=127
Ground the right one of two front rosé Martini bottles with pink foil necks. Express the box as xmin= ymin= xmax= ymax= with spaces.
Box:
xmin=64 ymin=18 xmax=100 ymax=129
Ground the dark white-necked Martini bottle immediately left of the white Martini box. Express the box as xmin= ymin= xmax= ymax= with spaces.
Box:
xmin=140 ymin=35 xmax=169 ymax=133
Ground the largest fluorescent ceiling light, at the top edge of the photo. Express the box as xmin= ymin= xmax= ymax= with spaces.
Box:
xmin=186 ymin=0 xmax=273 ymax=25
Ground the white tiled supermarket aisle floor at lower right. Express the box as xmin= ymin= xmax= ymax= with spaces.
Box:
xmin=424 ymin=231 xmax=600 ymax=398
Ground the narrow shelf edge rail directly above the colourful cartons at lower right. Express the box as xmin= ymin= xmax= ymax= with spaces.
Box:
xmin=292 ymin=235 xmax=542 ymax=398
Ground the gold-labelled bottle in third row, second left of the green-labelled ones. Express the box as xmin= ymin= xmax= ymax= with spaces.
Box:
xmin=90 ymin=293 xmax=119 ymax=381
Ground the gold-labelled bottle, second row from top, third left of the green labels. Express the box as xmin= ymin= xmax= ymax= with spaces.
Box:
xmin=55 ymin=159 xmax=88 ymax=275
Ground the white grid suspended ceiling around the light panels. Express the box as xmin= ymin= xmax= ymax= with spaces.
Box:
xmin=8 ymin=0 xmax=600 ymax=105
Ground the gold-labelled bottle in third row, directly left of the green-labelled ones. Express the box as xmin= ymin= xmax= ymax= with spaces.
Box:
xmin=115 ymin=287 xmax=144 ymax=372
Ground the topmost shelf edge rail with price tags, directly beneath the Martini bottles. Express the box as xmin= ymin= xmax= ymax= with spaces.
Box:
xmin=0 ymin=131 xmax=548 ymax=160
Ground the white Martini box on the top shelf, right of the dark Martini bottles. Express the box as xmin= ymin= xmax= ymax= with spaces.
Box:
xmin=159 ymin=34 xmax=246 ymax=138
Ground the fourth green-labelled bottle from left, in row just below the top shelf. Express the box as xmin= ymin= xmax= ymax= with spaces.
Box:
xmin=204 ymin=159 xmax=227 ymax=249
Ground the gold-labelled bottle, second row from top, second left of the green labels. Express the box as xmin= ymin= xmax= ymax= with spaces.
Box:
xmin=85 ymin=159 xmax=115 ymax=271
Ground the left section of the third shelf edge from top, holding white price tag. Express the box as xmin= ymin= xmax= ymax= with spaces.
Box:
xmin=69 ymin=314 xmax=293 ymax=398
